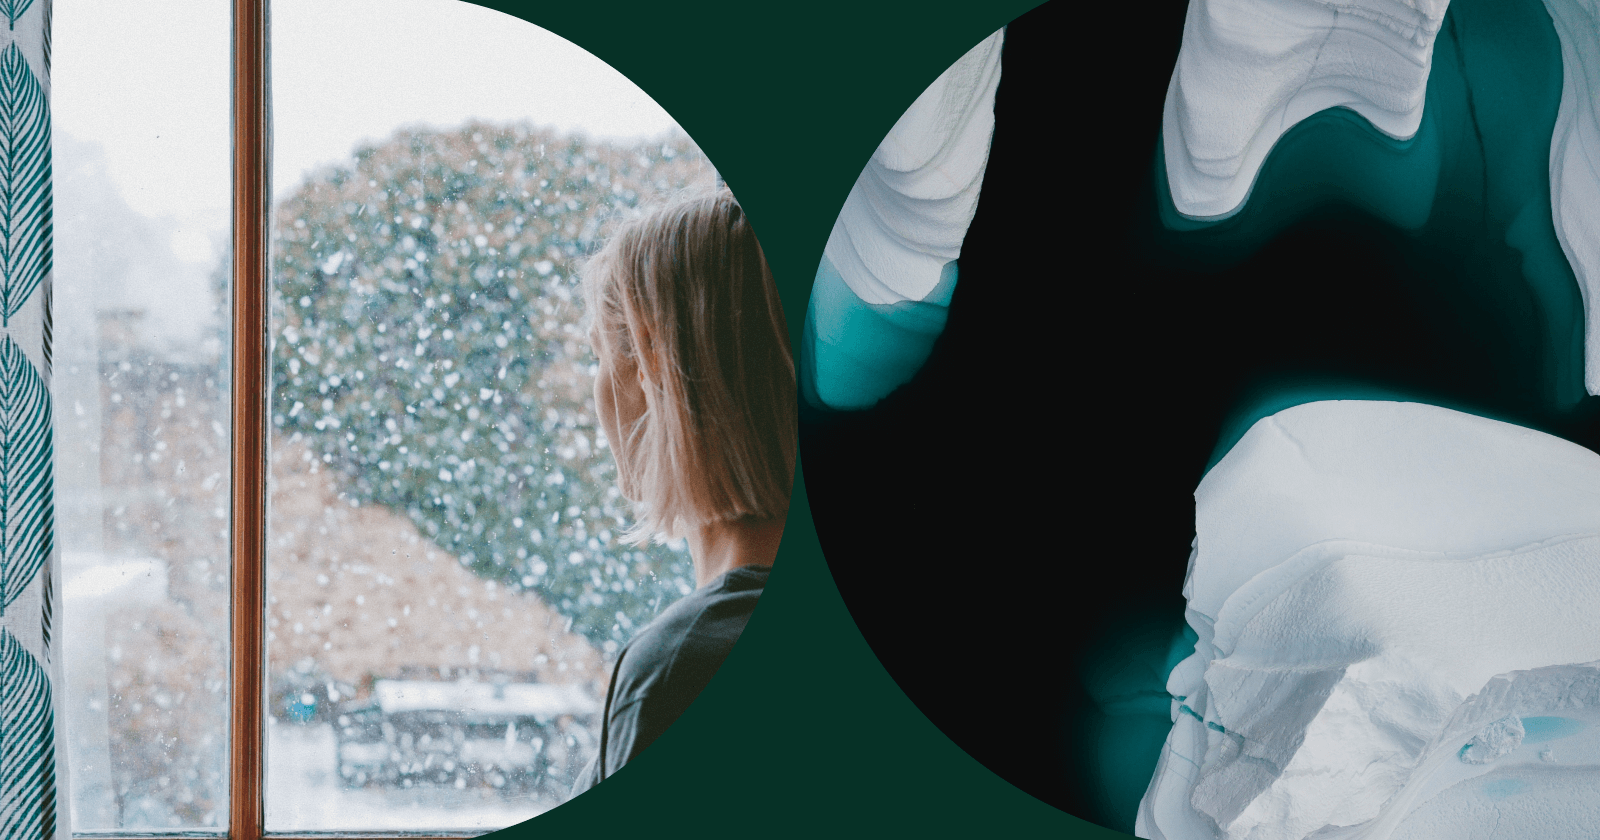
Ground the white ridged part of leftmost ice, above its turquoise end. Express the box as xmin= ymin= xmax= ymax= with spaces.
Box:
xmin=824 ymin=30 xmax=1005 ymax=304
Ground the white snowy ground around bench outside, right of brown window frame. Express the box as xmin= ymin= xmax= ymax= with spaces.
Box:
xmin=267 ymin=723 xmax=554 ymax=832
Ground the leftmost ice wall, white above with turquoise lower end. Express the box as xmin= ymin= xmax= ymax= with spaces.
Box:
xmin=805 ymin=30 xmax=1003 ymax=410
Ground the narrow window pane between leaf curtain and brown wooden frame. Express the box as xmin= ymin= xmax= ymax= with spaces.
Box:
xmin=51 ymin=0 xmax=230 ymax=830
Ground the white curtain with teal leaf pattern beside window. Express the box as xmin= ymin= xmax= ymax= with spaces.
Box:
xmin=0 ymin=0 xmax=70 ymax=840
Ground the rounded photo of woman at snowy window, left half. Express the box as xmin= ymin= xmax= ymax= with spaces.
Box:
xmin=56 ymin=0 xmax=798 ymax=837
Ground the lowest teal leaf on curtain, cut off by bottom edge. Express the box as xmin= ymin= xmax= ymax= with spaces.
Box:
xmin=0 ymin=629 xmax=56 ymax=840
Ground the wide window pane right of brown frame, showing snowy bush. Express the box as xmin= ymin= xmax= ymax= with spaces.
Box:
xmin=267 ymin=0 xmax=715 ymax=830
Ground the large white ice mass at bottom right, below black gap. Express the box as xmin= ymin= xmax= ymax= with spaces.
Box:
xmin=1136 ymin=402 xmax=1600 ymax=840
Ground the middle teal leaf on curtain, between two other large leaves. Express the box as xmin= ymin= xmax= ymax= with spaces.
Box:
xmin=0 ymin=336 xmax=47 ymax=611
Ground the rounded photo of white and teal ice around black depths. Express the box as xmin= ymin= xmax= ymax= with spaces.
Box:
xmin=800 ymin=0 xmax=1600 ymax=840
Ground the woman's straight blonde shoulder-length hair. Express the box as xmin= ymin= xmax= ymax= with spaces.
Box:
xmin=582 ymin=187 xmax=798 ymax=544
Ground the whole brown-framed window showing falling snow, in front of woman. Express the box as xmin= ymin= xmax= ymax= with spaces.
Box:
xmin=54 ymin=0 xmax=714 ymax=837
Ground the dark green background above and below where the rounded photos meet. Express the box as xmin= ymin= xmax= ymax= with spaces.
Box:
xmin=451 ymin=0 xmax=1126 ymax=838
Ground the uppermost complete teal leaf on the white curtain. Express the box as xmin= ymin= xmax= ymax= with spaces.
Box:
xmin=0 ymin=41 xmax=51 ymax=326
